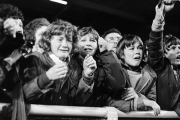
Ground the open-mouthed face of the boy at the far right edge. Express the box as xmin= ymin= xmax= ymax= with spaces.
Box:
xmin=165 ymin=45 xmax=180 ymax=65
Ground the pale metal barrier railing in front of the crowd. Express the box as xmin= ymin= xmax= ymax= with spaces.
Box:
xmin=0 ymin=103 xmax=180 ymax=120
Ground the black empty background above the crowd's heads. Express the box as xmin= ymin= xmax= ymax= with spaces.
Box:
xmin=0 ymin=0 xmax=180 ymax=41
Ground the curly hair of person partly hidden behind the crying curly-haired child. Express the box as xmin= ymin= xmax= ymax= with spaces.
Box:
xmin=24 ymin=18 xmax=50 ymax=41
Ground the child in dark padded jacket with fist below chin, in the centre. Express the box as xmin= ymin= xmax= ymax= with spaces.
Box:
xmin=72 ymin=27 xmax=124 ymax=107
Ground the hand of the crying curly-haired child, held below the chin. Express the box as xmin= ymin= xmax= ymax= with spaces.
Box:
xmin=46 ymin=63 xmax=68 ymax=80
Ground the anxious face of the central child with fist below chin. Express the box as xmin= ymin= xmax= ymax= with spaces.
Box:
xmin=76 ymin=34 xmax=98 ymax=57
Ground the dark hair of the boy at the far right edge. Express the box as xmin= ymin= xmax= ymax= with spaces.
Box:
xmin=163 ymin=34 xmax=180 ymax=52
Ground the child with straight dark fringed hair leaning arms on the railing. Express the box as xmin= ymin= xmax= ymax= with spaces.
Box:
xmin=108 ymin=34 xmax=160 ymax=115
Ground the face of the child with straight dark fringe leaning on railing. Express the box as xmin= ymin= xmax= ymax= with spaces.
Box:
xmin=122 ymin=42 xmax=143 ymax=67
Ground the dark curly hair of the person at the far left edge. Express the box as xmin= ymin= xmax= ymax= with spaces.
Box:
xmin=0 ymin=4 xmax=24 ymax=22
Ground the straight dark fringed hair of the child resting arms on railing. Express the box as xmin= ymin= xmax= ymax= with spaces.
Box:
xmin=116 ymin=34 xmax=144 ymax=60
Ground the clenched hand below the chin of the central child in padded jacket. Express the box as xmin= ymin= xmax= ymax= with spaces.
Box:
xmin=83 ymin=54 xmax=97 ymax=76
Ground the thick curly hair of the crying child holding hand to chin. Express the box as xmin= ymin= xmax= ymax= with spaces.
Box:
xmin=38 ymin=19 xmax=77 ymax=52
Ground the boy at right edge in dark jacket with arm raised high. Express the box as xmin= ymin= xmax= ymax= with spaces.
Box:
xmin=147 ymin=0 xmax=180 ymax=115
